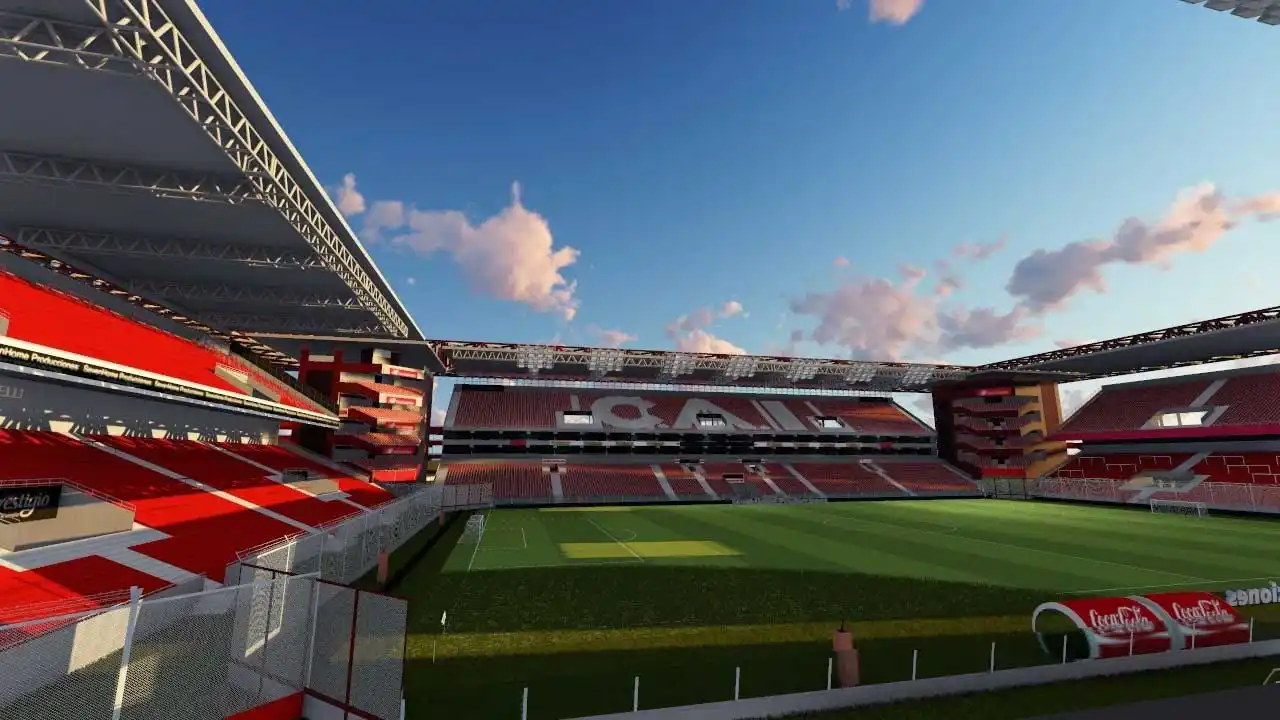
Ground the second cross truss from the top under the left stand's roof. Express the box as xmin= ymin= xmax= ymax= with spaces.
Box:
xmin=0 ymin=150 xmax=262 ymax=205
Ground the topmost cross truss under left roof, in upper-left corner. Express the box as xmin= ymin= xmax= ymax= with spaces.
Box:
xmin=0 ymin=12 xmax=143 ymax=74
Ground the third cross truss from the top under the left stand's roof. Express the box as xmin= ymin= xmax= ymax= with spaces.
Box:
xmin=17 ymin=227 xmax=325 ymax=270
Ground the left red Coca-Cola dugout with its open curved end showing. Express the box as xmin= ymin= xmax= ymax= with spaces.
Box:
xmin=1032 ymin=597 xmax=1172 ymax=660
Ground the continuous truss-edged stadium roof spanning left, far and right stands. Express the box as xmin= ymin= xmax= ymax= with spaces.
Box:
xmin=0 ymin=0 xmax=1280 ymax=392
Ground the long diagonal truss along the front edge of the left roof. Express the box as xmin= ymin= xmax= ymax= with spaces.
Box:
xmin=63 ymin=0 xmax=410 ymax=337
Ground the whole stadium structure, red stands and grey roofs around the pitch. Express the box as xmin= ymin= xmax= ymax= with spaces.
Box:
xmin=0 ymin=0 xmax=1280 ymax=717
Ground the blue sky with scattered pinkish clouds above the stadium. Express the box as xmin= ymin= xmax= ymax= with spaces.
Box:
xmin=202 ymin=0 xmax=1280 ymax=422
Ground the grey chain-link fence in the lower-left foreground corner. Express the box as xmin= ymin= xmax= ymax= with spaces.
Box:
xmin=0 ymin=566 xmax=407 ymax=720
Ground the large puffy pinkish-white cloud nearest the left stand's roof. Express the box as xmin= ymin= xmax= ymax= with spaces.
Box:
xmin=345 ymin=183 xmax=580 ymax=320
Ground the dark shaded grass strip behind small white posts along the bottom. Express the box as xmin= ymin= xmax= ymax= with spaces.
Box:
xmin=406 ymin=633 xmax=1052 ymax=720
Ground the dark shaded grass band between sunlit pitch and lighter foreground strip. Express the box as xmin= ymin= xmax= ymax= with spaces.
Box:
xmin=398 ymin=565 xmax=1061 ymax=633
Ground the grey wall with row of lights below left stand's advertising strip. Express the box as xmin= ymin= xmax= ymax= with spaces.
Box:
xmin=0 ymin=373 xmax=279 ymax=443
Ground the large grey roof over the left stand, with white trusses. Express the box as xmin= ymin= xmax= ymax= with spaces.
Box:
xmin=0 ymin=0 xmax=422 ymax=338
